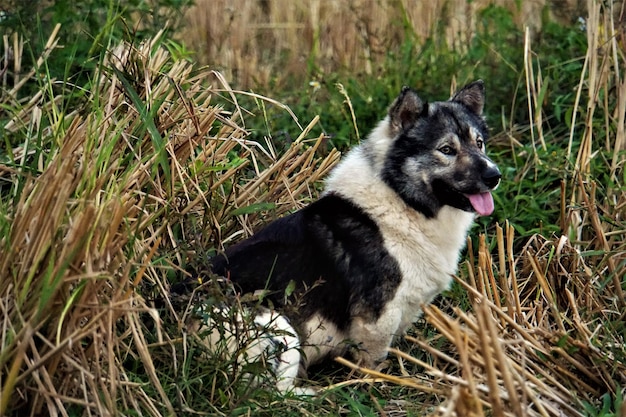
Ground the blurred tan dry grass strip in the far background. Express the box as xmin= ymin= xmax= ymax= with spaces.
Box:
xmin=181 ymin=0 xmax=585 ymax=88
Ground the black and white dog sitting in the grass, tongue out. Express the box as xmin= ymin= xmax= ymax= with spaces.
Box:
xmin=195 ymin=80 xmax=501 ymax=394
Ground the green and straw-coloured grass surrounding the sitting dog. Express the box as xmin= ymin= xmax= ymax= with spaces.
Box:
xmin=0 ymin=1 xmax=626 ymax=416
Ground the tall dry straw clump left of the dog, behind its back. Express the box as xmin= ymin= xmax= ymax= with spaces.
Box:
xmin=0 ymin=28 xmax=338 ymax=416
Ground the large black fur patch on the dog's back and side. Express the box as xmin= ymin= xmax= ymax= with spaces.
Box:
xmin=212 ymin=193 xmax=401 ymax=330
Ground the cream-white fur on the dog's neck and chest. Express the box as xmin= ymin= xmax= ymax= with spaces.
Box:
xmin=327 ymin=149 xmax=474 ymax=359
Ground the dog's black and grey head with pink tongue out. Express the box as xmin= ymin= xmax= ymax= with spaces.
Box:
xmin=372 ymin=80 xmax=501 ymax=217
